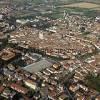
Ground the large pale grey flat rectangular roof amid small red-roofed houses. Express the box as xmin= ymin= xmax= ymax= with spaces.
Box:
xmin=23 ymin=59 xmax=53 ymax=73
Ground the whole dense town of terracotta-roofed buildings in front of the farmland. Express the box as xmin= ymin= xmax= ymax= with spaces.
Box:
xmin=0 ymin=9 xmax=100 ymax=100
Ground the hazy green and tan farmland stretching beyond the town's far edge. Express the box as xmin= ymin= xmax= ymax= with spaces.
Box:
xmin=0 ymin=0 xmax=100 ymax=19
